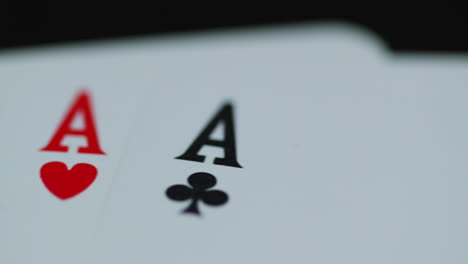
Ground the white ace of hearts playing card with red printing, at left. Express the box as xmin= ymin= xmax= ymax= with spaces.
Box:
xmin=0 ymin=46 xmax=149 ymax=263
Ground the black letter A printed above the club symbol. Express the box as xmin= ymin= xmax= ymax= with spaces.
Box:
xmin=176 ymin=103 xmax=242 ymax=168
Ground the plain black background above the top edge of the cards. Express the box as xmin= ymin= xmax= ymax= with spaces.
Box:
xmin=0 ymin=4 xmax=468 ymax=53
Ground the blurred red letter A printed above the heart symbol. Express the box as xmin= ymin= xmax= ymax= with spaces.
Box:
xmin=41 ymin=91 xmax=106 ymax=155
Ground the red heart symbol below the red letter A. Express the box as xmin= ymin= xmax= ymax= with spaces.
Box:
xmin=41 ymin=161 xmax=97 ymax=200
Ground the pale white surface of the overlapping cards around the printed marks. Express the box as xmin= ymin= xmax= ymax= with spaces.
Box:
xmin=0 ymin=23 xmax=468 ymax=264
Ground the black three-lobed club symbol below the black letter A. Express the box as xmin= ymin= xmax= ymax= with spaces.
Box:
xmin=166 ymin=172 xmax=228 ymax=215
